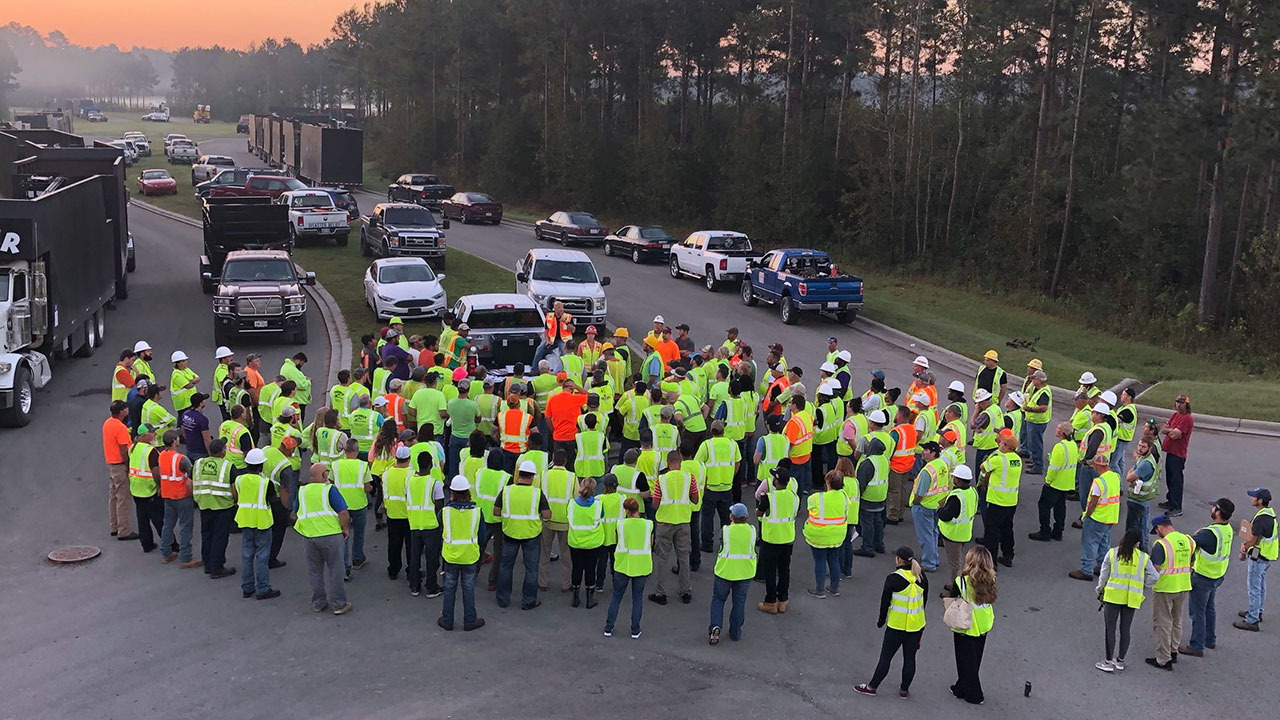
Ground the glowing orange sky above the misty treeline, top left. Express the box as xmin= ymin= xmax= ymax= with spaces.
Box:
xmin=8 ymin=0 xmax=364 ymax=50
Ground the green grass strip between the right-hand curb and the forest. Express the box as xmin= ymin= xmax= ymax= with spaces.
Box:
xmin=864 ymin=277 xmax=1280 ymax=420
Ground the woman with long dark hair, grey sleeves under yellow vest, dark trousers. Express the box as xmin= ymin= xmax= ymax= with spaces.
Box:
xmin=1093 ymin=528 xmax=1160 ymax=673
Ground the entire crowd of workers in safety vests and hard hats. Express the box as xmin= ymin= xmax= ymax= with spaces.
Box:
xmin=104 ymin=306 xmax=1277 ymax=703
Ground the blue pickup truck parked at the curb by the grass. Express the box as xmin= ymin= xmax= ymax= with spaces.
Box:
xmin=742 ymin=247 xmax=863 ymax=325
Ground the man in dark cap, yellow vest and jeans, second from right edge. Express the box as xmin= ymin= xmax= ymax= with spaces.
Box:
xmin=1178 ymin=497 xmax=1235 ymax=657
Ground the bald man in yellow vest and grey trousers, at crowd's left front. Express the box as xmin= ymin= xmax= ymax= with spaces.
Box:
xmin=293 ymin=464 xmax=351 ymax=615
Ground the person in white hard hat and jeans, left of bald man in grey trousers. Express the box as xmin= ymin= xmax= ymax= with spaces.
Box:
xmin=232 ymin=448 xmax=289 ymax=600
